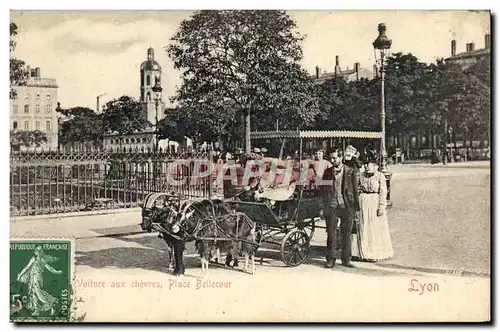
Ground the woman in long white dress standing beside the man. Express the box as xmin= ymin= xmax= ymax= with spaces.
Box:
xmin=352 ymin=161 xmax=394 ymax=261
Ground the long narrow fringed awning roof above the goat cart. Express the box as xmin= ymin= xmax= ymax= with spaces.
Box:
xmin=250 ymin=130 xmax=382 ymax=139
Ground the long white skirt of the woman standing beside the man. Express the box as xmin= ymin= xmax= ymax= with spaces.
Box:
xmin=352 ymin=193 xmax=394 ymax=261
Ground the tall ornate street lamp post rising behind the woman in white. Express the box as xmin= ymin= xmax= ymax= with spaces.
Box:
xmin=373 ymin=23 xmax=392 ymax=206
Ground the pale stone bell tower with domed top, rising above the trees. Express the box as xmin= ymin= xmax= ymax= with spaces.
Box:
xmin=141 ymin=47 xmax=165 ymax=126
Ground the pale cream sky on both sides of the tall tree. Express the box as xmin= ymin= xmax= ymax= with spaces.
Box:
xmin=10 ymin=10 xmax=490 ymax=109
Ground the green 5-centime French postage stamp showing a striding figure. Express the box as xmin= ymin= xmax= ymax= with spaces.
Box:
xmin=10 ymin=238 xmax=75 ymax=322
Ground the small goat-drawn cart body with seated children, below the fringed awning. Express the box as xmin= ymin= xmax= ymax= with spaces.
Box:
xmin=220 ymin=154 xmax=324 ymax=266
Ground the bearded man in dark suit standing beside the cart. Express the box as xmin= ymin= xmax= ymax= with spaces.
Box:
xmin=321 ymin=149 xmax=360 ymax=268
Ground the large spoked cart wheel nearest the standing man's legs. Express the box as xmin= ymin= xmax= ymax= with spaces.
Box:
xmin=281 ymin=229 xmax=311 ymax=266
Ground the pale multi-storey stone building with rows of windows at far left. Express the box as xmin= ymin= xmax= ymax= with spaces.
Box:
xmin=10 ymin=66 xmax=58 ymax=150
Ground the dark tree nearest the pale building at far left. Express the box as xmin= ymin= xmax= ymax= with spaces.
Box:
xmin=59 ymin=107 xmax=103 ymax=145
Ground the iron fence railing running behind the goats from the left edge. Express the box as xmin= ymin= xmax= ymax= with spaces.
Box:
xmin=10 ymin=151 xmax=213 ymax=216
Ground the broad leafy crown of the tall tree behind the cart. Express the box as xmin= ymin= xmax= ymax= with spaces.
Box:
xmin=167 ymin=10 xmax=318 ymax=146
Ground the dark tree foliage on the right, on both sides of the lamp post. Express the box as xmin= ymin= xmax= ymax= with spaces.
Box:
xmin=315 ymin=53 xmax=491 ymax=147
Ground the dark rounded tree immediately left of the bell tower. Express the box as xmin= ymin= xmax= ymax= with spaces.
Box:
xmin=102 ymin=96 xmax=151 ymax=136
